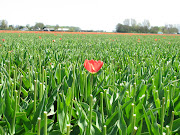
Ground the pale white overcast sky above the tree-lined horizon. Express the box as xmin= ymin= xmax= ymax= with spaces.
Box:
xmin=0 ymin=0 xmax=180 ymax=32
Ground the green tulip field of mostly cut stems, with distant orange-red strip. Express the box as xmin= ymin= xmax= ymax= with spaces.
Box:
xmin=0 ymin=31 xmax=180 ymax=135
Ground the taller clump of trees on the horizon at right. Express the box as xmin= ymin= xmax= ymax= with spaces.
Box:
xmin=116 ymin=19 xmax=180 ymax=34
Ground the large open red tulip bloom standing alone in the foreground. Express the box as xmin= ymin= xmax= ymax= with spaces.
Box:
xmin=84 ymin=59 xmax=103 ymax=73
